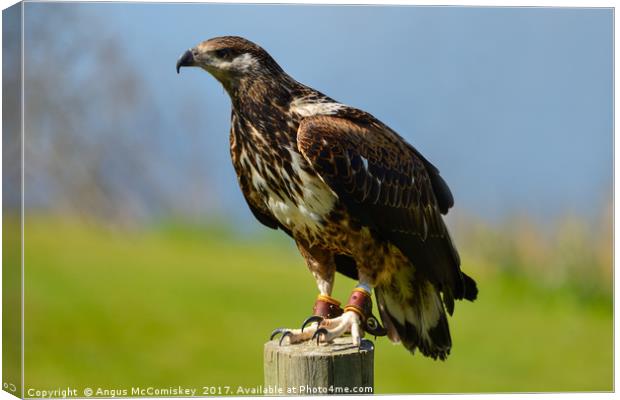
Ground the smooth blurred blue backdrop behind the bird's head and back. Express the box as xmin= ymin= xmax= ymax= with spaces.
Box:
xmin=26 ymin=3 xmax=613 ymax=220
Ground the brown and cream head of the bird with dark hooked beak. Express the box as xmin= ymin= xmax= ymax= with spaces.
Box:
xmin=177 ymin=36 xmax=282 ymax=90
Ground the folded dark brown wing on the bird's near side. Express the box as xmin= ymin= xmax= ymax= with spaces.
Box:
xmin=297 ymin=111 xmax=474 ymax=313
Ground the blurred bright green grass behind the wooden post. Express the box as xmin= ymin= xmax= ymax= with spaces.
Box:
xmin=18 ymin=219 xmax=613 ymax=393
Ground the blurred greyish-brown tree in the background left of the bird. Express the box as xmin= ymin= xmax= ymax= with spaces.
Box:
xmin=25 ymin=4 xmax=218 ymax=223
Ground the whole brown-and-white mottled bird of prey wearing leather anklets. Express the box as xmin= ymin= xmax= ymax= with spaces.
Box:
xmin=176 ymin=36 xmax=478 ymax=360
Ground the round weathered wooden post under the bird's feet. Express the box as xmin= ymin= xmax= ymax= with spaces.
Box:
xmin=264 ymin=337 xmax=374 ymax=395
